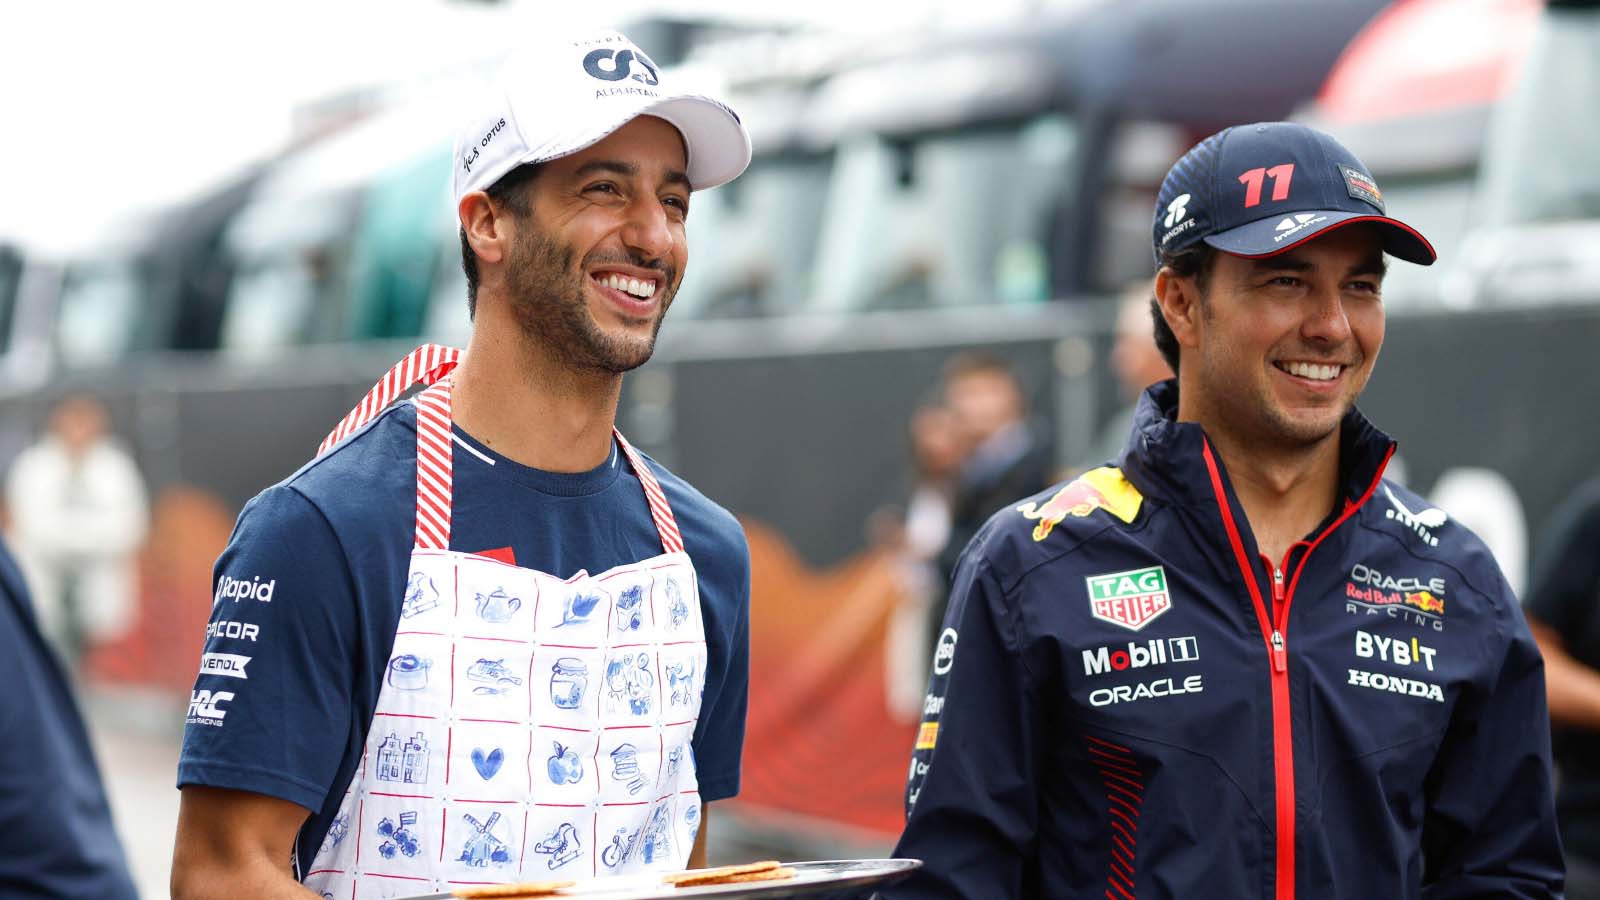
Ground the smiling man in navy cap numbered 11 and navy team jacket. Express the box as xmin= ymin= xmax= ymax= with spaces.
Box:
xmin=885 ymin=123 xmax=1563 ymax=900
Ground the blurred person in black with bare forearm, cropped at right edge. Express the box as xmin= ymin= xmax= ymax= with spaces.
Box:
xmin=1528 ymin=479 xmax=1600 ymax=900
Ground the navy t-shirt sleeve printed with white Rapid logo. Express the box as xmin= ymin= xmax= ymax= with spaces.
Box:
xmin=178 ymin=485 xmax=357 ymax=810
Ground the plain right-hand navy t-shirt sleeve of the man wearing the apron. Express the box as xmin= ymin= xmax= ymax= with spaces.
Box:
xmin=694 ymin=527 xmax=750 ymax=802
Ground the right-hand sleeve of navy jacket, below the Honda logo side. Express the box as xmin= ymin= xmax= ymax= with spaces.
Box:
xmin=1422 ymin=581 xmax=1565 ymax=900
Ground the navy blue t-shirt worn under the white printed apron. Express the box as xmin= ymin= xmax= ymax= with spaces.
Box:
xmin=178 ymin=404 xmax=750 ymax=868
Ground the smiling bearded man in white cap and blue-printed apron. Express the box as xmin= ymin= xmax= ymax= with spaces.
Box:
xmin=173 ymin=32 xmax=750 ymax=898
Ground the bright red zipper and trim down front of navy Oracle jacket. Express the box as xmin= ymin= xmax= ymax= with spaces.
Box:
xmin=1202 ymin=440 xmax=1394 ymax=900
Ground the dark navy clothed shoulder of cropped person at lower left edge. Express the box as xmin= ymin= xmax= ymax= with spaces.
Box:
xmin=0 ymin=531 xmax=138 ymax=900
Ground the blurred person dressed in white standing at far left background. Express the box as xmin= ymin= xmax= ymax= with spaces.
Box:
xmin=6 ymin=394 xmax=149 ymax=668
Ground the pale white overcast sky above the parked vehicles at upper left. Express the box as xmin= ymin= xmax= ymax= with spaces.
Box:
xmin=0 ymin=0 xmax=1048 ymax=248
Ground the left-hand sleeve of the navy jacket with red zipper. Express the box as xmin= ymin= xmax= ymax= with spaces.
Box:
xmin=883 ymin=536 xmax=1042 ymax=900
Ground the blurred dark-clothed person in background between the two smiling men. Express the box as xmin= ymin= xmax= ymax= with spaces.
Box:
xmin=930 ymin=351 xmax=1051 ymax=659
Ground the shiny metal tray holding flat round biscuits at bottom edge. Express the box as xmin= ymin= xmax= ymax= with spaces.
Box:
xmin=405 ymin=860 xmax=922 ymax=900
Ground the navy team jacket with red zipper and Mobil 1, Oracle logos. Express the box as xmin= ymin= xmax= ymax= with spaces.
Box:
xmin=883 ymin=381 xmax=1563 ymax=900
